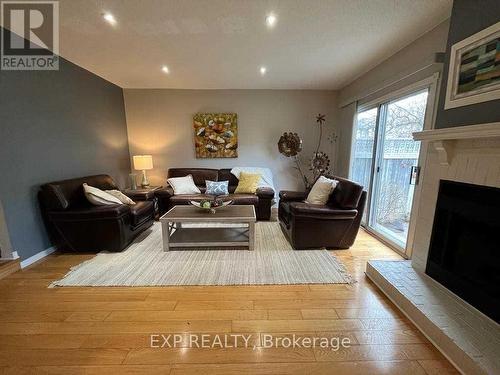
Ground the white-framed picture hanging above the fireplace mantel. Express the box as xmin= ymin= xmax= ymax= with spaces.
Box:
xmin=444 ymin=22 xmax=500 ymax=109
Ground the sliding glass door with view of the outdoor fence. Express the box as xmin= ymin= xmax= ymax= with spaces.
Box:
xmin=350 ymin=89 xmax=429 ymax=250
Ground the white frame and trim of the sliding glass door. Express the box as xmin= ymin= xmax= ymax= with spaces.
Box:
xmin=349 ymin=72 xmax=440 ymax=259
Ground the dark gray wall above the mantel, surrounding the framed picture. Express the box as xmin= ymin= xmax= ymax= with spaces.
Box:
xmin=435 ymin=0 xmax=500 ymax=128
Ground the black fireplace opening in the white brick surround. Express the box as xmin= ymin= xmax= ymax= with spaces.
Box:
xmin=425 ymin=180 xmax=500 ymax=323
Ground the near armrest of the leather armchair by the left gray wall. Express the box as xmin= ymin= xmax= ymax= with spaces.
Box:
xmin=48 ymin=204 xmax=130 ymax=221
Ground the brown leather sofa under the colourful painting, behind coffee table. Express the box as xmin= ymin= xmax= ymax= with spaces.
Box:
xmin=155 ymin=168 xmax=274 ymax=220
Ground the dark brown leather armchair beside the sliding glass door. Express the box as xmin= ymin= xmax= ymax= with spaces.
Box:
xmin=278 ymin=176 xmax=366 ymax=250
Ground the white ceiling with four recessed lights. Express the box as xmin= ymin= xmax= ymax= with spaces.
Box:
xmin=55 ymin=0 xmax=452 ymax=89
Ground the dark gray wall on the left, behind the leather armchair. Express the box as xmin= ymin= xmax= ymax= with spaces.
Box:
xmin=0 ymin=55 xmax=130 ymax=259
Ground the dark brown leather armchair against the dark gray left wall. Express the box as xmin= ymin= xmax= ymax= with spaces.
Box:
xmin=39 ymin=175 xmax=154 ymax=252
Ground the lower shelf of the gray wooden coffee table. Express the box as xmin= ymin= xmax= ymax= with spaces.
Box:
xmin=164 ymin=227 xmax=253 ymax=251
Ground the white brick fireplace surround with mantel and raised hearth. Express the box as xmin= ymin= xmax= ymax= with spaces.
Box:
xmin=366 ymin=123 xmax=500 ymax=374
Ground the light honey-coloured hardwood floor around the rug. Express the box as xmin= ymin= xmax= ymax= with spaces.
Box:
xmin=0 ymin=232 xmax=456 ymax=375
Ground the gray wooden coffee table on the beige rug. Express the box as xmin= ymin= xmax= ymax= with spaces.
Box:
xmin=160 ymin=205 xmax=256 ymax=251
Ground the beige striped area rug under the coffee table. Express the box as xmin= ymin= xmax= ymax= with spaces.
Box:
xmin=51 ymin=222 xmax=353 ymax=287
